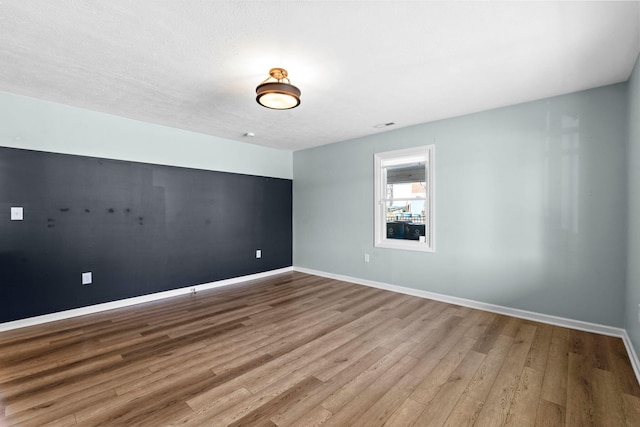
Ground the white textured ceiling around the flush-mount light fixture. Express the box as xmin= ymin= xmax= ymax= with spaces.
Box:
xmin=0 ymin=0 xmax=640 ymax=150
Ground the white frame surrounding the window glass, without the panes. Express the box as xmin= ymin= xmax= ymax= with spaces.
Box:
xmin=374 ymin=145 xmax=436 ymax=252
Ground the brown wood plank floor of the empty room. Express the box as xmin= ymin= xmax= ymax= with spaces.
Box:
xmin=0 ymin=273 xmax=640 ymax=427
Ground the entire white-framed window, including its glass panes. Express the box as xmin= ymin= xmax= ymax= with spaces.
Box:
xmin=374 ymin=145 xmax=435 ymax=252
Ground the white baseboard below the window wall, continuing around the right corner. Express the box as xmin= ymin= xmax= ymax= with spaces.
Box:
xmin=293 ymin=266 xmax=640 ymax=383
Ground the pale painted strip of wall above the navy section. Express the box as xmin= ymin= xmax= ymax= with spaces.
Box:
xmin=0 ymin=92 xmax=293 ymax=179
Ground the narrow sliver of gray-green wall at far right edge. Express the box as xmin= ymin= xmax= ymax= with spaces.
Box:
xmin=625 ymin=53 xmax=640 ymax=354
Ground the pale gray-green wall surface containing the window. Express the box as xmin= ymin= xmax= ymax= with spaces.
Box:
xmin=293 ymin=84 xmax=640 ymax=327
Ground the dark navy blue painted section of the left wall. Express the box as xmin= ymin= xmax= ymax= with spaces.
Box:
xmin=0 ymin=148 xmax=292 ymax=322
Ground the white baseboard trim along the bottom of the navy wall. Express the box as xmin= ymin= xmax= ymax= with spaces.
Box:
xmin=0 ymin=267 xmax=293 ymax=332
